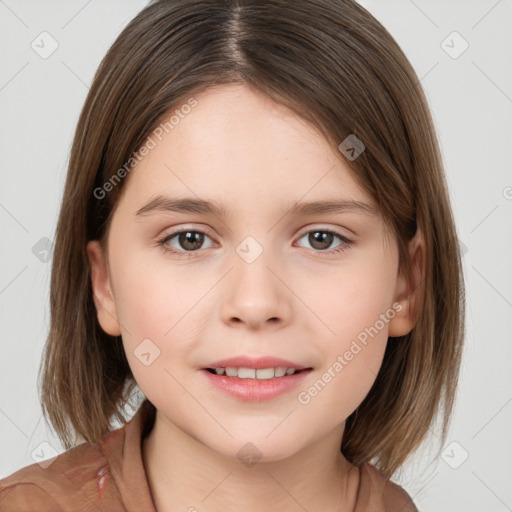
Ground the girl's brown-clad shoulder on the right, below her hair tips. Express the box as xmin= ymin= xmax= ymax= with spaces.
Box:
xmin=358 ymin=463 xmax=418 ymax=512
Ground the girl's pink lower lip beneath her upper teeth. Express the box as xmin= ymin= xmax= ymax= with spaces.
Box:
xmin=201 ymin=369 xmax=312 ymax=402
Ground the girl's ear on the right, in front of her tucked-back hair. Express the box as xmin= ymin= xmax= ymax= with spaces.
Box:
xmin=388 ymin=228 xmax=425 ymax=337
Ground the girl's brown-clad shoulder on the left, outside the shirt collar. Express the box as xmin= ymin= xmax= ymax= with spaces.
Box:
xmin=0 ymin=443 xmax=121 ymax=512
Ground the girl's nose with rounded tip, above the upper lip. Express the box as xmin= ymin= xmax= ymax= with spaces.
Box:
xmin=221 ymin=246 xmax=292 ymax=330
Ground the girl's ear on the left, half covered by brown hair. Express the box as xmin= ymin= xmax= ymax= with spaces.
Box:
xmin=87 ymin=240 xmax=121 ymax=336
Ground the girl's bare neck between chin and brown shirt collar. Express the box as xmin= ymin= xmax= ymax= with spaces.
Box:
xmin=142 ymin=411 xmax=359 ymax=512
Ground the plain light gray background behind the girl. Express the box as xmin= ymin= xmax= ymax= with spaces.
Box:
xmin=0 ymin=0 xmax=512 ymax=512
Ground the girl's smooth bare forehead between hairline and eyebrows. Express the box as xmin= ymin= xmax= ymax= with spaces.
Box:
xmin=125 ymin=81 xmax=370 ymax=212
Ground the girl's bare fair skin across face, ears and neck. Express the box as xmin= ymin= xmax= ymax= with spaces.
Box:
xmin=87 ymin=85 xmax=423 ymax=512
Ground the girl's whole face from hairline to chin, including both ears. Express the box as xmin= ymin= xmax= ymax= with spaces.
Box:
xmin=88 ymin=85 xmax=412 ymax=460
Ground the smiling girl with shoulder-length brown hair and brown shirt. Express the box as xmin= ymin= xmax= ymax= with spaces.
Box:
xmin=0 ymin=0 xmax=464 ymax=512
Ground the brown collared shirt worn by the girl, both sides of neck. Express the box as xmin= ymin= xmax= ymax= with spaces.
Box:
xmin=0 ymin=400 xmax=417 ymax=512
